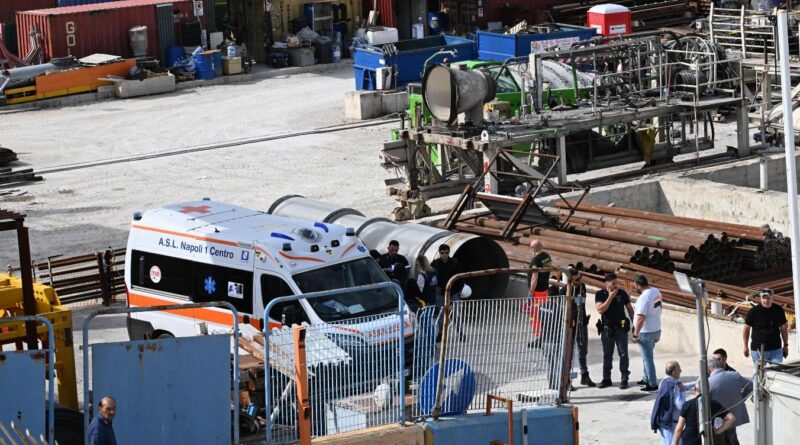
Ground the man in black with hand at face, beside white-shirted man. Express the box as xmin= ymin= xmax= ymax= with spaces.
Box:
xmin=594 ymin=273 xmax=633 ymax=389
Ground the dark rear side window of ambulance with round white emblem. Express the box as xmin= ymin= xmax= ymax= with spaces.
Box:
xmin=131 ymin=250 xmax=192 ymax=298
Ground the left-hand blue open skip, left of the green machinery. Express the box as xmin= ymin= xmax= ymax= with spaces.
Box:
xmin=353 ymin=35 xmax=477 ymax=90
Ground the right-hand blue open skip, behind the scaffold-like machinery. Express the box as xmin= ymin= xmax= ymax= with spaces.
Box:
xmin=477 ymin=25 xmax=597 ymax=62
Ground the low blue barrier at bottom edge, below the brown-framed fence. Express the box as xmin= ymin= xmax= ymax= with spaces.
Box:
xmin=425 ymin=406 xmax=577 ymax=445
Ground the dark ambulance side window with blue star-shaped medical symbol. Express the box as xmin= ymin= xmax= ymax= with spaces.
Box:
xmin=192 ymin=263 xmax=253 ymax=314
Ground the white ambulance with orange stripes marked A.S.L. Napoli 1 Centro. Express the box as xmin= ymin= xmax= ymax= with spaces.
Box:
xmin=125 ymin=198 xmax=414 ymax=351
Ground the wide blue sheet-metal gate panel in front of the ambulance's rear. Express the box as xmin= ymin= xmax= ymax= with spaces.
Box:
xmin=83 ymin=302 xmax=239 ymax=445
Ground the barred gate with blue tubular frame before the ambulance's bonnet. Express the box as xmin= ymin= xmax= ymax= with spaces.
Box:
xmin=264 ymin=282 xmax=412 ymax=444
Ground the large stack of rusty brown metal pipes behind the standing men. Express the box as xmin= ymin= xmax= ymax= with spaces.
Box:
xmin=444 ymin=202 xmax=794 ymax=315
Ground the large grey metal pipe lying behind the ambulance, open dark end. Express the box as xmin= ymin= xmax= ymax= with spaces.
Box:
xmin=267 ymin=195 xmax=508 ymax=298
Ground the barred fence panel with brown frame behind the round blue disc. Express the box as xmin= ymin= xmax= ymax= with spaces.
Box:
xmin=411 ymin=296 xmax=567 ymax=417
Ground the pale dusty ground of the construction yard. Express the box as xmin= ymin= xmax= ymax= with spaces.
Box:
xmin=0 ymin=64 xmax=752 ymax=444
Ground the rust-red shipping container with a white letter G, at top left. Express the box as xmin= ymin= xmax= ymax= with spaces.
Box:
xmin=17 ymin=0 xmax=194 ymax=59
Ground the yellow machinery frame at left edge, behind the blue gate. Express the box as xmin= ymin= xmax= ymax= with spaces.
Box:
xmin=0 ymin=273 xmax=78 ymax=410
